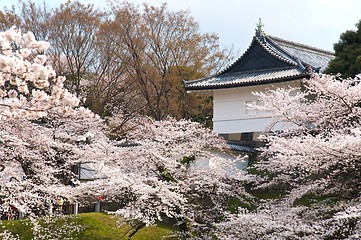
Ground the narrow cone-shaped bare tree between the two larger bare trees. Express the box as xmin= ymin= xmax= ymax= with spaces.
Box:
xmin=85 ymin=18 xmax=143 ymax=119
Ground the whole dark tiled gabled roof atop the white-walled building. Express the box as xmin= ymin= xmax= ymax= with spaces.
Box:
xmin=184 ymin=30 xmax=333 ymax=90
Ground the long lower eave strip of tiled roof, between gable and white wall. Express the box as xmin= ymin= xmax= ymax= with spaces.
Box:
xmin=186 ymin=67 xmax=307 ymax=90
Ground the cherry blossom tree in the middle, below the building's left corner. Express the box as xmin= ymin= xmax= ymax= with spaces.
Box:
xmin=76 ymin=116 xmax=248 ymax=237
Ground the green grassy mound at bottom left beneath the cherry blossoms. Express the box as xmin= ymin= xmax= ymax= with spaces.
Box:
xmin=0 ymin=213 xmax=176 ymax=240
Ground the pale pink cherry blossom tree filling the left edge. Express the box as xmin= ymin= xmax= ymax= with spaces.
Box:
xmin=0 ymin=27 xmax=98 ymax=219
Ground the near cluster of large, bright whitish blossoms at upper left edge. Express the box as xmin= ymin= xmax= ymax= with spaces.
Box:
xmin=0 ymin=27 xmax=92 ymax=119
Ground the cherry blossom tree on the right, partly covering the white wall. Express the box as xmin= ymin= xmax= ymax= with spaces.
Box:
xmin=218 ymin=75 xmax=361 ymax=239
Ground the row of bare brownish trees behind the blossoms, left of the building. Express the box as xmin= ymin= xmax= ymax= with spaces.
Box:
xmin=0 ymin=1 xmax=233 ymax=124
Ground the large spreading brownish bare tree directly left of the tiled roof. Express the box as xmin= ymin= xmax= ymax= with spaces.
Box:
xmin=109 ymin=3 xmax=229 ymax=120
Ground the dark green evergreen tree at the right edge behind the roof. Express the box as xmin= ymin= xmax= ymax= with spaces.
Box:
xmin=325 ymin=20 xmax=361 ymax=78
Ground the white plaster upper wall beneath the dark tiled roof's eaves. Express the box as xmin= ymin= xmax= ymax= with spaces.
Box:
xmin=213 ymin=80 xmax=300 ymax=133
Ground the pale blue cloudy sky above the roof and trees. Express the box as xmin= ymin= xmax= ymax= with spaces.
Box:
xmin=0 ymin=0 xmax=361 ymax=53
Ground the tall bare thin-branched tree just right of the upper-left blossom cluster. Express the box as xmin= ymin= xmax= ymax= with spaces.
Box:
xmin=49 ymin=1 xmax=106 ymax=96
